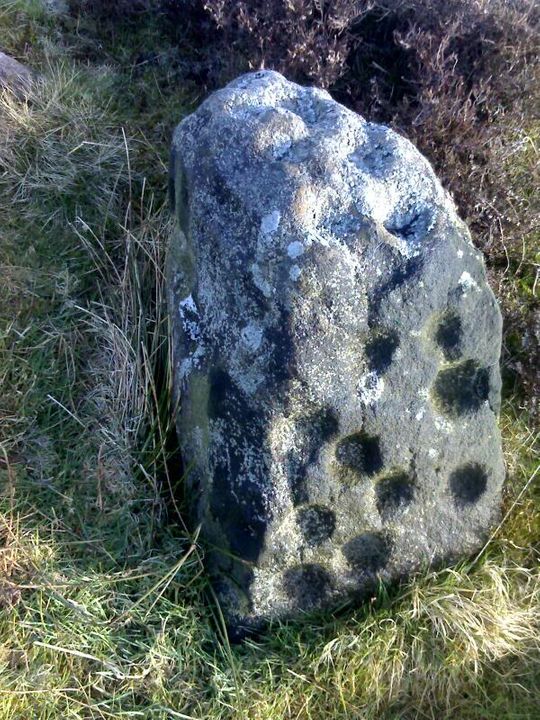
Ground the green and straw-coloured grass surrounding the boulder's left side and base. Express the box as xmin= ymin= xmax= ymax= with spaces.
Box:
xmin=0 ymin=2 xmax=540 ymax=720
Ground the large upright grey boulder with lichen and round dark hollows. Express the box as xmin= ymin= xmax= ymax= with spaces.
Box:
xmin=168 ymin=72 xmax=504 ymax=628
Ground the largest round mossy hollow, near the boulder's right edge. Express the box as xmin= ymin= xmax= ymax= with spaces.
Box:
xmin=433 ymin=360 xmax=489 ymax=417
